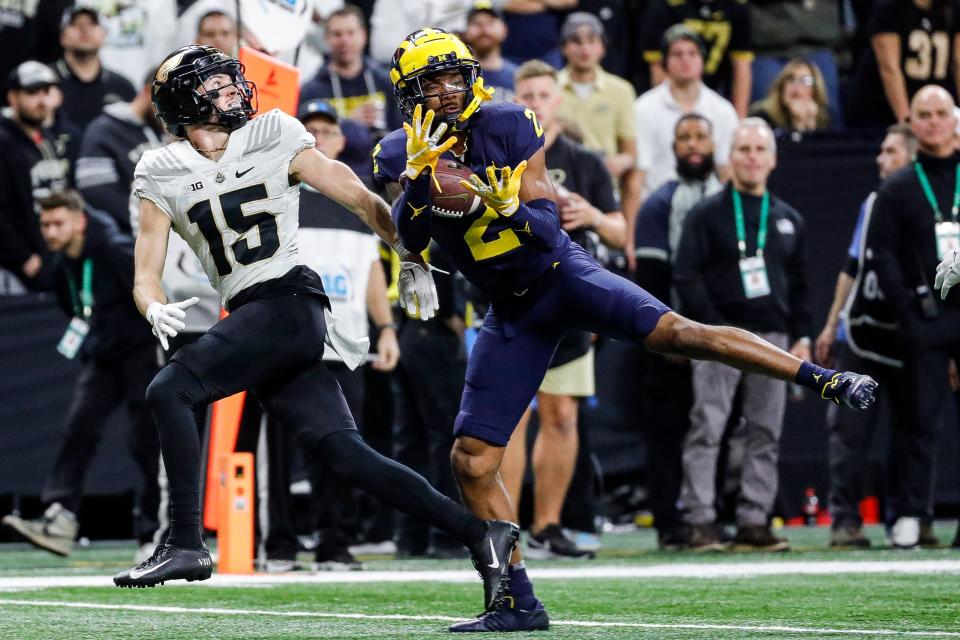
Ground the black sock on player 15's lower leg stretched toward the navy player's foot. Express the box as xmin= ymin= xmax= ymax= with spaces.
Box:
xmin=317 ymin=429 xmax=487 ymax=548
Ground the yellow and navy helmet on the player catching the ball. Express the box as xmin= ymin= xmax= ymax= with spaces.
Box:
xmin=390 ymin=28 xmax=493 ymax=130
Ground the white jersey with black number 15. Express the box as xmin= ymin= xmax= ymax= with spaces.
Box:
xmin=134 ymin=109 xmax=314 ymax=306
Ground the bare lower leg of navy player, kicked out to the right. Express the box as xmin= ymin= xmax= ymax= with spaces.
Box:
xmin=643 ymin=312 xmax=803 ymax=381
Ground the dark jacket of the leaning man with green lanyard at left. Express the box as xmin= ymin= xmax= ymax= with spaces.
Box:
xmin=52 ymin=209 xmax=153 ymax=360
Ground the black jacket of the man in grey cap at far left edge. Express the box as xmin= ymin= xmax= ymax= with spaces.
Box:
xmin=0 ymin=116 xmax=69 ymax=287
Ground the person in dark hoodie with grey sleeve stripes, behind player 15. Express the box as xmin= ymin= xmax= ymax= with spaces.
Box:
xmin=76 ymin=69 xmax=163 ymax=233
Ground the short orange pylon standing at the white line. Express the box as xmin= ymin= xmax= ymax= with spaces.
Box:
xmin=217 ymin=453 xmax=254 ymax=573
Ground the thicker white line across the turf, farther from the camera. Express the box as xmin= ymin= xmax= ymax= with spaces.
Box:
xmin=0 ymin=559 xmax=960 ymax=590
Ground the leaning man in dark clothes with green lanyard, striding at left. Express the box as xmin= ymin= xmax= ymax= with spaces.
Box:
xmin=3 ymin=189 xmax=160 ymax=556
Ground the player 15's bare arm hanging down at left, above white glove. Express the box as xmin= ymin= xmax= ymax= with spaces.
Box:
xmin=133 ymin=199 xmax=170 ymax=317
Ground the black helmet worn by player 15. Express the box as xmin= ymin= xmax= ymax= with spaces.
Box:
xmin=152 ymin=45 xmax=257 ymax=138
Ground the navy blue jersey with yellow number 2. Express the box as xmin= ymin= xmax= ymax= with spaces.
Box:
xmin=373 ymin=103 xmax=570 ymax=299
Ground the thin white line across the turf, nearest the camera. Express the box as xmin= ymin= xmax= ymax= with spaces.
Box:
xmin=0 ymin=598 xmax=960 ymax=638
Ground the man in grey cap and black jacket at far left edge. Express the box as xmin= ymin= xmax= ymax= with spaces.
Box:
xmin=0 ymin=60 xmax=70 ymax=290
